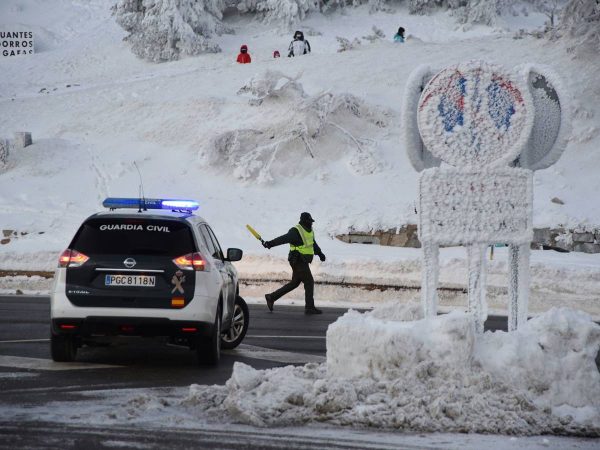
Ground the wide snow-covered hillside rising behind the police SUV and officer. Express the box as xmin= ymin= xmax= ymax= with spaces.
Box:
xmin=0 ymin=0 xmax=600 ymax=312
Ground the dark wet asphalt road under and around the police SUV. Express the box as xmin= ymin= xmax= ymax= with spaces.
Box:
xmin=0 ymin=296 xmax=506 ymax=450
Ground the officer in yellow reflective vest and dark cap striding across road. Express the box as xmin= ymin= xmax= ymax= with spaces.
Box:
xmin=263 ymin=212 xmax=325 ymax=314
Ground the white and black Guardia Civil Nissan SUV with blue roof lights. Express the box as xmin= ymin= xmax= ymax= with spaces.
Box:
xmin=51 ymin=198 xmax=249 ymax=364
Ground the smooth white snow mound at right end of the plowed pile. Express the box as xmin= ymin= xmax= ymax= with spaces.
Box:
xmin=474 ymin=308 xmax=600 ymax=414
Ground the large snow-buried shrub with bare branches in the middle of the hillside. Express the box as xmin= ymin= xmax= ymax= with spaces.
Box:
xmin=199 ymin=71 xmax=389 ymax=183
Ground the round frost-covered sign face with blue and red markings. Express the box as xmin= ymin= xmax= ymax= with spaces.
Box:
xmin=418 ymin=62 xmax=527 ymax=169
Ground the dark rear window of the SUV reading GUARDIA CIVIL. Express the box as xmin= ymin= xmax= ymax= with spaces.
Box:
xmin=71 ymin=218 xmax=196 ymax=256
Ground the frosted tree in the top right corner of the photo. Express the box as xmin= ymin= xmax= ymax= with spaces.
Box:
xmin=559 ymin=0 xmax=600 ymax=51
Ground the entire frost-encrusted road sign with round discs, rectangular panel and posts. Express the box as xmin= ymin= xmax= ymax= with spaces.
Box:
xmin=403 ymin=61 xmax=568 ymax=332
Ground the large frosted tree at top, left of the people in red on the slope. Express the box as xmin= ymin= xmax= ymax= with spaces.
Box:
xmin=113 ymin=0 xmax=229 ymax=62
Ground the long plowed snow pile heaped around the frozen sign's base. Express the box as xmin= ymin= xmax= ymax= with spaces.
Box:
xmin=187 ymin=305 xmax=600 ymax=436
